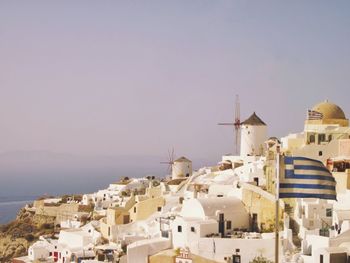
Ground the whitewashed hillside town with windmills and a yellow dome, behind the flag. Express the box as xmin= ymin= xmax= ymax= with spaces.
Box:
xmin=9 ymin=101 xmax=350 ymax=263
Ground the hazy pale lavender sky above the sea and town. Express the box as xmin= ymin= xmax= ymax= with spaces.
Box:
xmin=0 ymin=0 xmax=350 ymax=160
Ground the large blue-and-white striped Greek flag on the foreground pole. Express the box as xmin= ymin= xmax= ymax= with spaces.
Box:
xmin=279 ymin=156 xmax=336 ymax=200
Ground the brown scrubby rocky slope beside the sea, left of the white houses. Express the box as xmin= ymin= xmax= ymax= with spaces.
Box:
xmin=0 ymin=208 xmax=55 ymax=263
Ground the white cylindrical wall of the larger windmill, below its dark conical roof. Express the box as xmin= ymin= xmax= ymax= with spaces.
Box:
xmin=241 ymin=124 xmax=267 ymax=156
